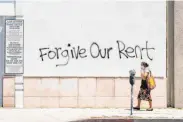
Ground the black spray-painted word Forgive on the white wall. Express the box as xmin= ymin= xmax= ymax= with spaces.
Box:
xmin=39 ymin=44 xmax=87 ymax=66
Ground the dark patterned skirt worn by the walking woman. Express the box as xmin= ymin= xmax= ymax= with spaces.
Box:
xmin=137 ymin=88 xmax=152 ymax=101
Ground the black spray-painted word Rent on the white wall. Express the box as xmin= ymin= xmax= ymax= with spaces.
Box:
xmin=116 ymin=40 xmax=155 ymax=61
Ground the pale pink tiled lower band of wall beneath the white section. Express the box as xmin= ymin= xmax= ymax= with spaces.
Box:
xmin=3 ymin=77 xmax=167 ymax=108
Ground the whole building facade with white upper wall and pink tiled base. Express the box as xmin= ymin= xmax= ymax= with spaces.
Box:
xmin=0 ymin=0 xmax=183 ymax=108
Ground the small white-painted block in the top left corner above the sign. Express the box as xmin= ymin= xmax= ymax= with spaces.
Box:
xmin=0 ymin=2 xmax=15 ymax=16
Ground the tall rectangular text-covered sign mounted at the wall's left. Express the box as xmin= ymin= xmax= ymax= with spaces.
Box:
xmin=5 ymin=20 xmax=24 ymax=74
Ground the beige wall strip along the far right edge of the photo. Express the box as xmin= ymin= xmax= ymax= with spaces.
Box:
xmin=174 ymin=1 xmax=183 ymax=108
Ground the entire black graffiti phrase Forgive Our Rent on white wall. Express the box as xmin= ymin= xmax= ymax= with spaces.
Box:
xmin=39 ymin=40 xmax=155 ymax=67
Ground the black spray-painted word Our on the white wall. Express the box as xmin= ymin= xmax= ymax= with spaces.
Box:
xmin=90 ymin=42 xmax=113 ymax=59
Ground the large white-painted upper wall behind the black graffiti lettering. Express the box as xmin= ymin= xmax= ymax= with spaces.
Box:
xmin=17 ymin=0 xmax=166 ymax=77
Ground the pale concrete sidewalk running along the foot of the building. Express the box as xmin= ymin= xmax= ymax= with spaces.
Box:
xmin=0 ymin=108 xmax=183 ymax=122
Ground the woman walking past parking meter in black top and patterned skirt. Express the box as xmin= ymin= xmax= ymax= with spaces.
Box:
xmin=134 ymin=62 xmax=153 ymax=111
